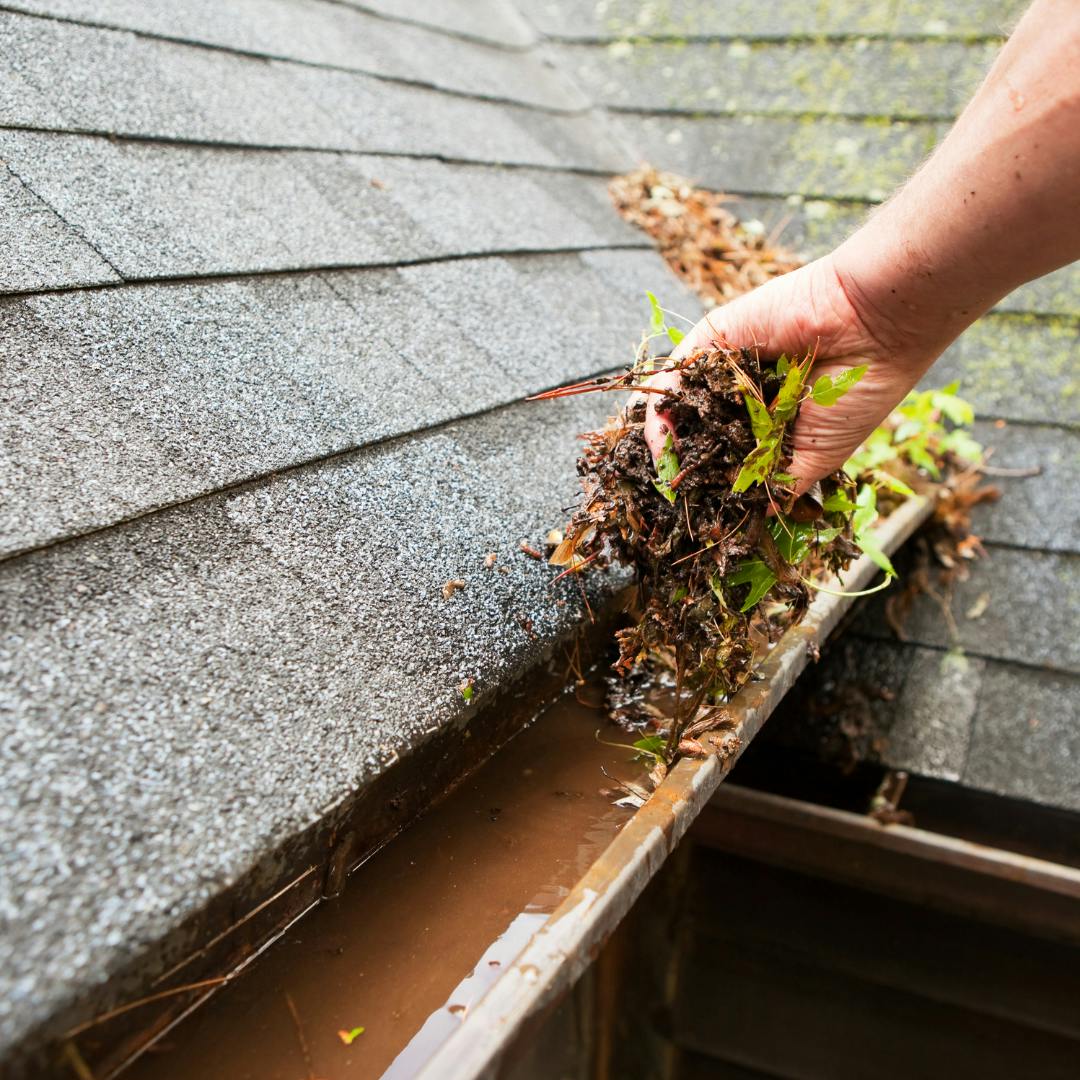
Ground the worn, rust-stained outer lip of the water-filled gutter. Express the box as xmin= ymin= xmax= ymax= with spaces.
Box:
xmin=408 ymin=496 xmax=933 ymax=1080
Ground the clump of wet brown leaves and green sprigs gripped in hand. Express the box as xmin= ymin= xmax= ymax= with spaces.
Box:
xmin=540 ymin=341 xmax=868 ymax=765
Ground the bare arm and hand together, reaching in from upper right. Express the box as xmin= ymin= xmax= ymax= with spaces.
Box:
xmin=645 ymin=0 xmax=1080 ymax=490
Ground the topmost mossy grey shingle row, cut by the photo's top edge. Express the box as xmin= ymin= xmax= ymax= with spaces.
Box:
xmin=527 ymin=0 xmax=1027 ymax=39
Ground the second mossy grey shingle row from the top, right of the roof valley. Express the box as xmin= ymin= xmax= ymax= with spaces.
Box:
xmin=557 ymin=38 xmax=998 ymax=119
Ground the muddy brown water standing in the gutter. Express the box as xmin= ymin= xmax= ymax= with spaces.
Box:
xmin=122 ymin=696 xmax=640 ymax=1080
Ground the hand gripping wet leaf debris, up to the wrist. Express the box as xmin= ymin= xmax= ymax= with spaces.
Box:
xmin=645 ymin=250 xmax=940 ymax=491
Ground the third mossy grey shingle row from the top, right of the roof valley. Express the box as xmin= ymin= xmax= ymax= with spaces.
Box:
xmin=613 ymin=116 xmax=943 ymax=201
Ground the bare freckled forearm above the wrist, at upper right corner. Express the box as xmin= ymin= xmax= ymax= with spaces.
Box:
xmin=833 ymin=0 xmax=1080 ymax=367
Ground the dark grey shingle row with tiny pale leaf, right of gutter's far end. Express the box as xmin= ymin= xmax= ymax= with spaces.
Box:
xmin=856 ymin=548 xmax=1080 ymax=673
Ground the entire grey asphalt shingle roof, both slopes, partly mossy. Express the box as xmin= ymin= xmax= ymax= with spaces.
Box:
xmin=0 ymin=0 xmax=1080 ymax=1067
